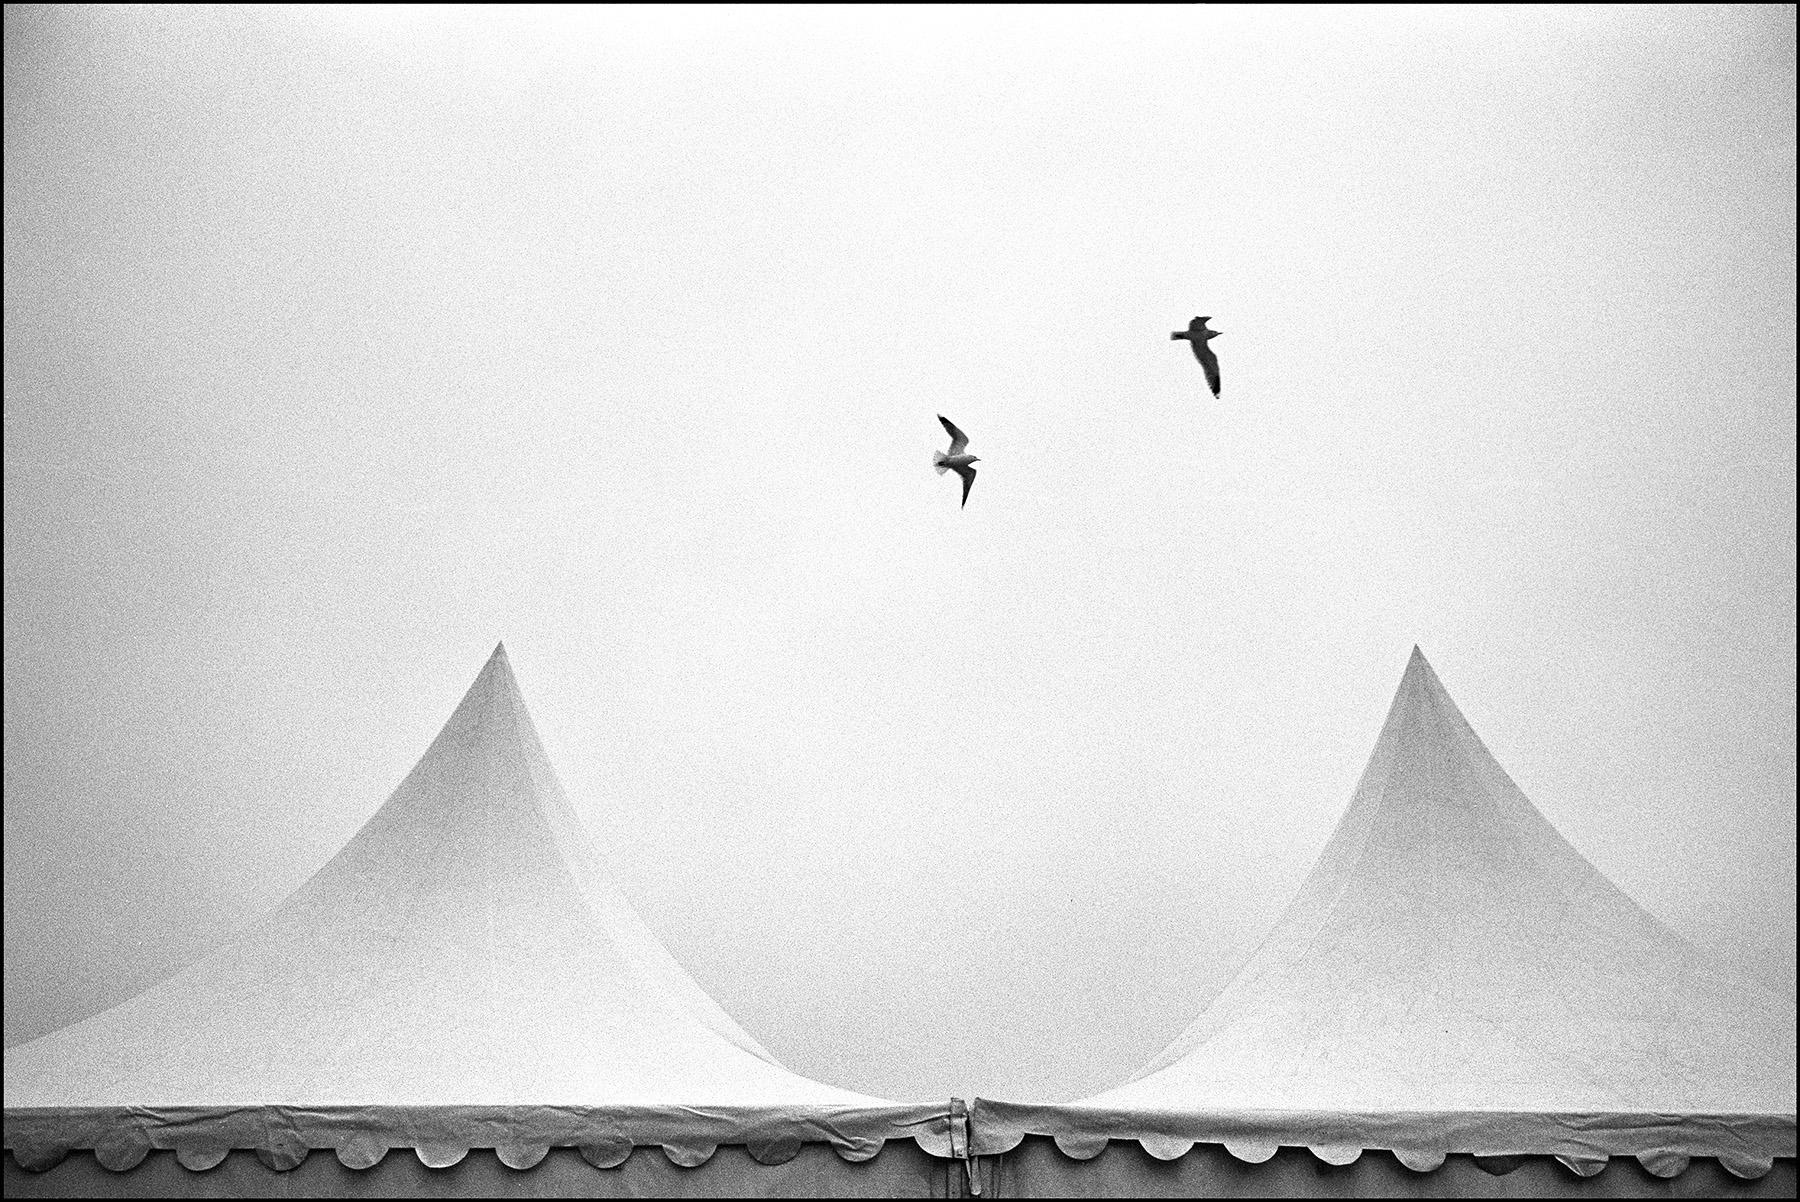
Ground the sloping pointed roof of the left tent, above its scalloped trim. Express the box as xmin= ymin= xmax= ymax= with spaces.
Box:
xmin=5 ymin=633 xmax=907 ymax=1122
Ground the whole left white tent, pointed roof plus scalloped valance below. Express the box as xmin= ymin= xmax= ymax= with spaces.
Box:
xmin=5 ymin=648 xmax=959 ymax=1193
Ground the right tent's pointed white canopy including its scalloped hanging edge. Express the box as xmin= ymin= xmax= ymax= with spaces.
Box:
xmin=972 ymin=648 xmax=1795 ymax=1171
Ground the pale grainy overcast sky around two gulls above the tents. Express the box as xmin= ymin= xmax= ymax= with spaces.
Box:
xmin=5 ymin=5 xmax=1795 ymax=1099
